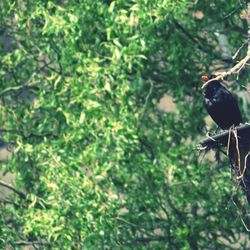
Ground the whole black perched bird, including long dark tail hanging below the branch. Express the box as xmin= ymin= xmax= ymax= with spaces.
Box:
xmin=202 ymin=76 xmax=250 ymax=205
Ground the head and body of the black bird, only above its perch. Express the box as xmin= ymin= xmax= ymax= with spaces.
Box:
xmin=202 ymin=76 xmax=242 ymax=129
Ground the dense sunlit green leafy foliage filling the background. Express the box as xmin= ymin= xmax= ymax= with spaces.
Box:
xmin=0 ymin=0 xmax=250 ymax=250
